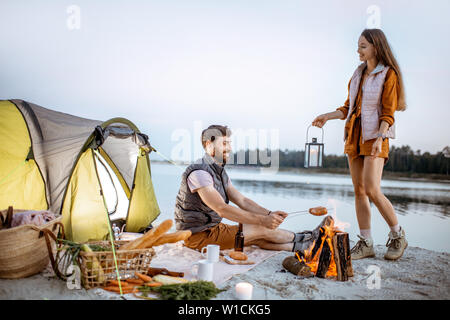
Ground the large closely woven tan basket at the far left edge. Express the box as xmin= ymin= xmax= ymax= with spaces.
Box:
xmin=0 ymin=209 xmax=61 ymax=279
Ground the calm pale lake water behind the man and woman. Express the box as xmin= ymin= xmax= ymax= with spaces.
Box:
xmin=151 ymin=162 xmax=450 ymax=252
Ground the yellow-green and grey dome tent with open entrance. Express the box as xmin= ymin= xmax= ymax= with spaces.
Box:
xmin=0 ymin=100 xmax=160 ymax=242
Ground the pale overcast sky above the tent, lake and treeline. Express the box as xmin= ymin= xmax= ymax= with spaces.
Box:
xmin=0 ymin=0 xmax=450 ymax=160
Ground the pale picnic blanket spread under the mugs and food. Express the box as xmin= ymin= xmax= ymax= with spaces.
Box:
xmin=150 ymin=241 xmax=279 ymax=285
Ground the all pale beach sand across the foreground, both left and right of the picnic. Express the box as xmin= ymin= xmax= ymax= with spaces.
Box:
xmin=0 ymin=245 xmax=450 ymax=300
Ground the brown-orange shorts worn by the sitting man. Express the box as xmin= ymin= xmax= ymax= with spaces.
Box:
xmin=184 ymin=223 xmax=239 ymax=250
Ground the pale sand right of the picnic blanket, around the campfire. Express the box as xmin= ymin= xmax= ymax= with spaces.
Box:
xmin=217 ymin=246 xmax=450 ymax=300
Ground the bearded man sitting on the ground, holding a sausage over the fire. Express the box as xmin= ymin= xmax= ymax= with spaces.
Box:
xmin=175 ymin=125 xmax=320 ymax=251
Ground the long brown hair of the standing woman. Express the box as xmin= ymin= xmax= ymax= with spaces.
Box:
xmin=361 ymin=29 xmax=406 ymax=111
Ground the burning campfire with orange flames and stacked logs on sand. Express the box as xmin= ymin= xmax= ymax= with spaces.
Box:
xmin=283 ymin=216 xmax=353 ymax=281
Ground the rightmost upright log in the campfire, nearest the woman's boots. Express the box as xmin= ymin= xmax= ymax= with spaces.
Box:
xmin=333 ymin=232 xmax=353 ymax=281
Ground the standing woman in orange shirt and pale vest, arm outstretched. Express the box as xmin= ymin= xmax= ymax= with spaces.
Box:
xmin=312 ymin=29 xmax=408 ymax=260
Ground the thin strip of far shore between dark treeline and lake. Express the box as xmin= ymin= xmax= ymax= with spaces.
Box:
xmin=152 ymin=160 xmax=450 ymax=184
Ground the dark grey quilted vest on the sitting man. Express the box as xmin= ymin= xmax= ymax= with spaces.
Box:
xmin=175 ymin=154 xmax=229 ymax=234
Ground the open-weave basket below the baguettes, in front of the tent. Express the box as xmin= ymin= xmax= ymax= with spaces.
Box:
xmin=79 ymin=241 xmax=155 ymax=289
